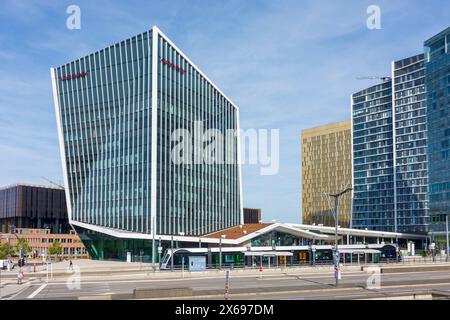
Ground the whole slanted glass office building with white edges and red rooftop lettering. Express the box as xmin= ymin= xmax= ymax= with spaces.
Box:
xmin=51 ymin=27 xmax=243 ymax=259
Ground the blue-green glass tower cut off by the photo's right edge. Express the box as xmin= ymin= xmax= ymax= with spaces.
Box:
xmin=425 ymin=28 xmax=450 ymax=240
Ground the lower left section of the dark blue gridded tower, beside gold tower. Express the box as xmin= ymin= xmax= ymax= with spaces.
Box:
xmin=351 ymin=80 xmax=395 ymax=231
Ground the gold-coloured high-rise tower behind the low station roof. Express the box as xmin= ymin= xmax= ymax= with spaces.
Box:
xmin=302 ymin=120 xmax=352 ymax=227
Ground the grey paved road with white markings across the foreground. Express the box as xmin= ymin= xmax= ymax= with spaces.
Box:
xmin=6 ymin=271 xmax=450 ymax=300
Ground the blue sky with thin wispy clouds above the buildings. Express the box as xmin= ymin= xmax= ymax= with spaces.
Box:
xmin=0 ymin=0 xmax=450 ymax=222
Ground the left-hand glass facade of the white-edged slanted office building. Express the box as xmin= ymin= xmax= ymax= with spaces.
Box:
xmin=54 ymin=32 xmax=152 ymax=233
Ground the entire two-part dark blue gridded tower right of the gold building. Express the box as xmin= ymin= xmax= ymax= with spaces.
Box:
xmin=352 ymin=54 xmax=428 ymax=233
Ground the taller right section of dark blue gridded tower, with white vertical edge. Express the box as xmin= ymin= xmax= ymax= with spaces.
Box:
xmin=392 ymin=54 xmax=428 ymax=233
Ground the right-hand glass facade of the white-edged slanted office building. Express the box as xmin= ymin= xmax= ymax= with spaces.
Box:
xmin=156 ymin=36 xmax=241 ymax=235
